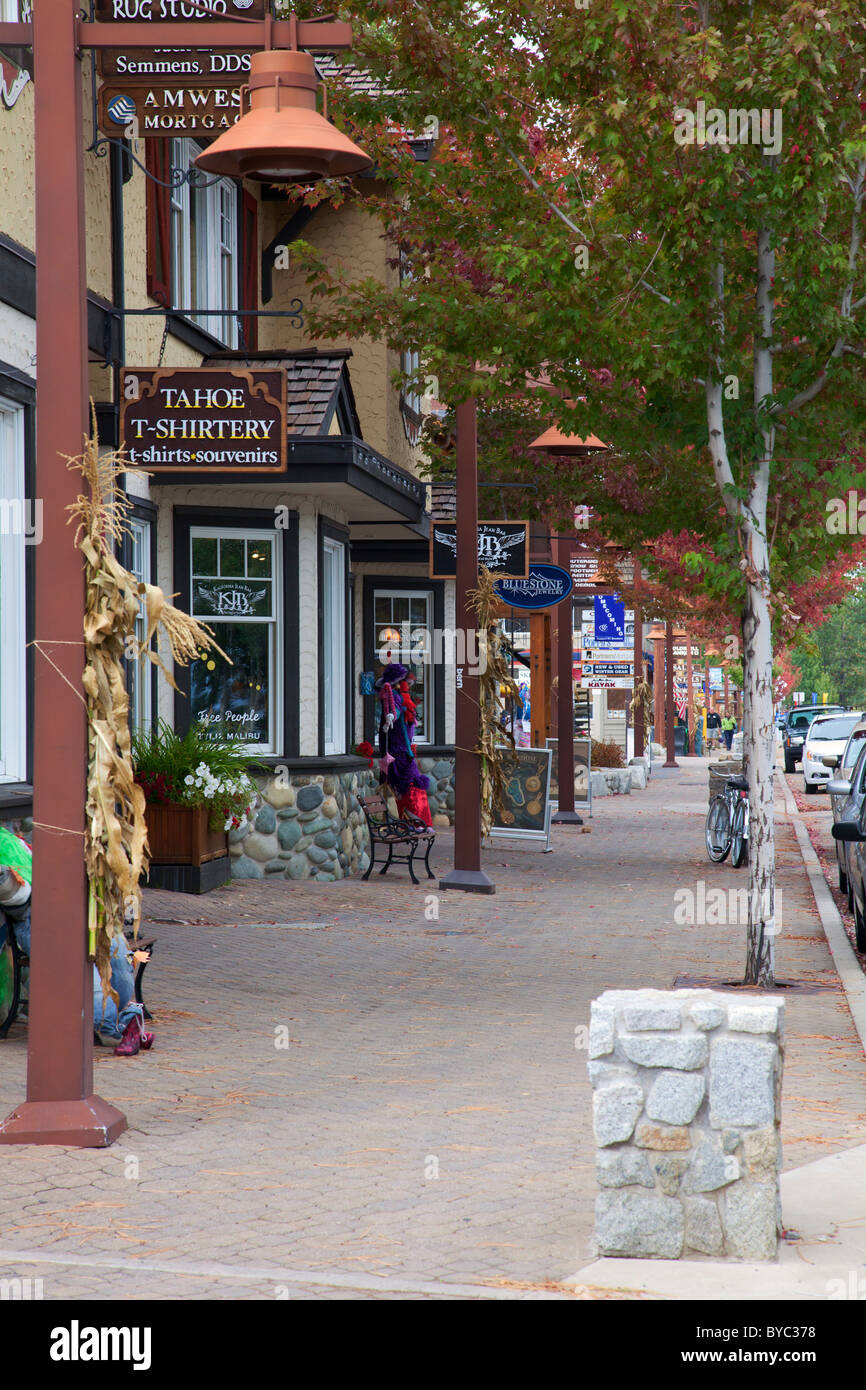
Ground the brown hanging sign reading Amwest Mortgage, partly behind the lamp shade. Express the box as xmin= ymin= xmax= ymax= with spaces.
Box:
xmin=99 ymin=82 xmax=240 ymax=139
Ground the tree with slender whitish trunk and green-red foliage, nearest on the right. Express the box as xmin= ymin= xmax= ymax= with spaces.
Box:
xmin=294 ymin=0 xmax=866 ymax=986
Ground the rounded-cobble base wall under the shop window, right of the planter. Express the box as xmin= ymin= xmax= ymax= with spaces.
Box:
xmin=228 ymin=770 xmax=377 ymax=883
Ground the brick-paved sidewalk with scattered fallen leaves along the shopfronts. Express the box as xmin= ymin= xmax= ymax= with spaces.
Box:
xmin=0 ymin=759 xmax=866 ymax=1298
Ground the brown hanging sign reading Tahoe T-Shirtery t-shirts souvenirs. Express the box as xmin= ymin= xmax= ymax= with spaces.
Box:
xmin=120 ymin=367 xmax=286 ymax=474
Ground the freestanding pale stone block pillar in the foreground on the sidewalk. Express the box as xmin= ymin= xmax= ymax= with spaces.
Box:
xmin=589 ymin=990 xmax=784 ymax=1259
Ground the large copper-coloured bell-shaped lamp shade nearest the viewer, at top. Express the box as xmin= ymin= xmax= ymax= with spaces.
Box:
xmin=196 ymin=49 xmax=373 ymax=183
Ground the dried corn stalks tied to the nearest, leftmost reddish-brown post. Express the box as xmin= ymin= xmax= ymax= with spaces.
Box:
xmin=68 ymin=414 xmax=228 ymax=997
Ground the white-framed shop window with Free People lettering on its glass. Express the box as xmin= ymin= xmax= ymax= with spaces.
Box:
xmin=189 ymin=527 xmax=282 ymax=753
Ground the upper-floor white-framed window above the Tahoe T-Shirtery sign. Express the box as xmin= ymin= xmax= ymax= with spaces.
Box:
xmin=171 ymin=140 xmax=238 ymax=348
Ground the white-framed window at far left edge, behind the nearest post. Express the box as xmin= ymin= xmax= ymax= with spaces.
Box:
xmin=0 ymin=398 xmax=26 ymax=783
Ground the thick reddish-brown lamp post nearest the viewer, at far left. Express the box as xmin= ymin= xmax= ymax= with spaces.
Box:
xmin=0 ymin=0 xmax=126 ymax=1148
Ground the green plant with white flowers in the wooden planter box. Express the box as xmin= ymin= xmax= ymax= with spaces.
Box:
xmin=132 ymin=719 xmax=259 ymax=830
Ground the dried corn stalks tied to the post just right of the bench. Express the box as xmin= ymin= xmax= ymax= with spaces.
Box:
xmin=468 ymin=569 xmax=520 ymax=835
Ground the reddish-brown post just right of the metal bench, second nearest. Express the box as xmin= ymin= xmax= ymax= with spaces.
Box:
xmin=439 ymin=400 xmax=496 ymax=892
